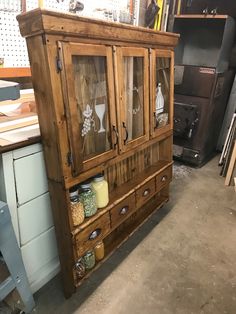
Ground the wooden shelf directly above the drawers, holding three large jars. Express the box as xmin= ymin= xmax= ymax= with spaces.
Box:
xmin=72 ymin=160 xmax=172 ymax=236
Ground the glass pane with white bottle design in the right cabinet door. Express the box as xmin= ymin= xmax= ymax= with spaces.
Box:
xmin=155 ymin=57 xmax=170 ymax=128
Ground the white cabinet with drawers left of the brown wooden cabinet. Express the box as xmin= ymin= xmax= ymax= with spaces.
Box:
xmin=0 ymin=144 xmax=59 ymax=292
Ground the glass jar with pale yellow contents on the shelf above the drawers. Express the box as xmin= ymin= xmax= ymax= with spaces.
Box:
xmin=92 ymin=173 xmax=109 ymax=208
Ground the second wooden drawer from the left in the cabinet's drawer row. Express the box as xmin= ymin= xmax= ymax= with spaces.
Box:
xmin=110 ymin=193 xmax=136 ymax=228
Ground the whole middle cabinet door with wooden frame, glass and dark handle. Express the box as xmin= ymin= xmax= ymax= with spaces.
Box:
xmin=115 ymin=48 xmax=149 ymax=151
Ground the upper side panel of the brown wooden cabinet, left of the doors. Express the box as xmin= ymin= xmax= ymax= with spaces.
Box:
xmin=27 ymin=36 xmax=69 ymax=181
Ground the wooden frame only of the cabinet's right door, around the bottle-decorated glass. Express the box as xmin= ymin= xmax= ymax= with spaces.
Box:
xmin=149 ymin=49 xmax=174 ymax=138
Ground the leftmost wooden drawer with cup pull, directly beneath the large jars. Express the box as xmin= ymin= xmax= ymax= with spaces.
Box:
xmin=75 ymin=212 xmax=110 ymax=257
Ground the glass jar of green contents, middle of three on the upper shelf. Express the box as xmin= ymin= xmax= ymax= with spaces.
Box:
xmin=79 ymin=181 xmax=97 ymax=217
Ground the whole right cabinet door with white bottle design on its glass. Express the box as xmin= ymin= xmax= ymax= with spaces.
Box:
xmin=150 ymin=50 xmax=173 ymax=137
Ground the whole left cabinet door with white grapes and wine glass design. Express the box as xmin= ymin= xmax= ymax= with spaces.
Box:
xmin=61 ymin=43 xmax=118 ymax=175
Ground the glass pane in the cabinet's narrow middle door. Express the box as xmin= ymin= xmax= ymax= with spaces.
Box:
xmin=123 ymin=57 xmax=144 ymax=141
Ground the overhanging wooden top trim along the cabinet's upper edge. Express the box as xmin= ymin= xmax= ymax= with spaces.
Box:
xmin=17 ymin=8 xmax=179 ymax=47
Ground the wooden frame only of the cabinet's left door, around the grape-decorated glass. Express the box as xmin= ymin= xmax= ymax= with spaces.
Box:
xmin=58 ymin=41 xmax=117 ymax=176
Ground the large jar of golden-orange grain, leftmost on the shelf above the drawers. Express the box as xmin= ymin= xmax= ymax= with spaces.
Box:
xmin=69 ymin=186 xmax=84 ymax=226
